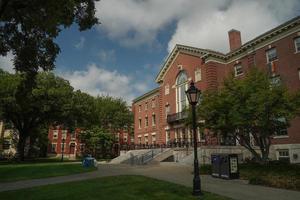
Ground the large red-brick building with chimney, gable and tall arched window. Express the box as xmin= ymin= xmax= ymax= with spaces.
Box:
xmin=132 ymin=17 xmax=300 ymax=162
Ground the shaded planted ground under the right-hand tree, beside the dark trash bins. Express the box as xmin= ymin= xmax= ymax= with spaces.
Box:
xmin=200 ymin=163 xmax=300 ymax=191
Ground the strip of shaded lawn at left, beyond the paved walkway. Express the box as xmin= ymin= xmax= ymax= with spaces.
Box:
xmin=0 ymin=163 xmax=96 ymax=182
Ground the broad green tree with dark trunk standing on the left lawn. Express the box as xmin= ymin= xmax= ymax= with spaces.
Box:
xmin=0 ymin=72 xmax=73 ymax=160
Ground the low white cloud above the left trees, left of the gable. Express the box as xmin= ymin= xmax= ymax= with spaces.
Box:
xmin=58 ymin=64 xmax=150 ymax=105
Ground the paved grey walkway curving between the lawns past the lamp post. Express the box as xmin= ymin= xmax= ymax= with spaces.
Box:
xmin=0 ymin=164 xmax=300 ymax=200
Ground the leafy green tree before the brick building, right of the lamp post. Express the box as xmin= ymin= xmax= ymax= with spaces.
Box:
xmin=198 ymin=68 xmax=300 ymax=163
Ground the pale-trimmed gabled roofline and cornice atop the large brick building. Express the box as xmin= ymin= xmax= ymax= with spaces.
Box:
xmin=155 ymin=16 xmax=300 ymax=83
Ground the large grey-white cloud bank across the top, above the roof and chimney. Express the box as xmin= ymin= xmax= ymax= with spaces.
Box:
xmin=96 ymin=0 xmax=300 ymax=52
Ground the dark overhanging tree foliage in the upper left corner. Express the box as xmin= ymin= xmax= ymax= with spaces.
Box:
xmin=0 ymin=0 xmax=98 ymax=75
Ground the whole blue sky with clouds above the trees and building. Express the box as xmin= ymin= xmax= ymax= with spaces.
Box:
xmin=0 ymin=0 xmax=300 ymax=104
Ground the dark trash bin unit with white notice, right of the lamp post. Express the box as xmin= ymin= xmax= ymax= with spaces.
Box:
xmin=211 ymin=154 xmax=239 ymax=179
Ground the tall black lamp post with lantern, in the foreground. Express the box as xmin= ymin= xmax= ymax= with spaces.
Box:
xmin=185 ymin=81 xmax=202 ymax=196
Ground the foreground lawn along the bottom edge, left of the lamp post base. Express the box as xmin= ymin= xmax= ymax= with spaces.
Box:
xmin=0 ymin=176 xmax=230 ymax=200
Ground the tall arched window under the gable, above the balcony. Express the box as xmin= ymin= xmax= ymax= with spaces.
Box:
xmin=176 ymin=71 xmax=188 ymax=112
